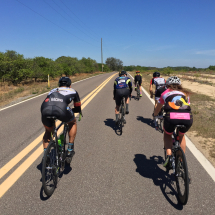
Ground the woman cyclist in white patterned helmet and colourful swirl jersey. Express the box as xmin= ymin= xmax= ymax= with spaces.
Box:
xmin=153 ymin=76 xmax=193 ymax=166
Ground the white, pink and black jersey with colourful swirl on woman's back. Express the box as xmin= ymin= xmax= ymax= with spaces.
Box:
xmin=158 ymin=89 xmax=191 ymax=112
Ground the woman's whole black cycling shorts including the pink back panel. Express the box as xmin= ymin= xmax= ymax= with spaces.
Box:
xmin=163 ymin=112 xmax=193 ymax=134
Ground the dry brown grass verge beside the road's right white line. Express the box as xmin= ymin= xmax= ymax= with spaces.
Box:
xmin=130 ymin=72 xmax=215 ymax=158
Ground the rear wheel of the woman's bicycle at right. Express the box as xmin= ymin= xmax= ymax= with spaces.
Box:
xmin=175 ymin=147 xmax=189 ymax=205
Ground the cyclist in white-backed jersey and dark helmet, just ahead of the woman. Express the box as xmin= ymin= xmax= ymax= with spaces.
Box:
xmin=149 ymin=72 xmax=166 ymax=111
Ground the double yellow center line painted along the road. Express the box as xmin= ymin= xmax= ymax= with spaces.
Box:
xmin=0 ymin=74 xmax=116 ymax=198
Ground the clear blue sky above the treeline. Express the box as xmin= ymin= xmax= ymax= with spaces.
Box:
xmin=0 ymin=0 xmax=215 ymax=68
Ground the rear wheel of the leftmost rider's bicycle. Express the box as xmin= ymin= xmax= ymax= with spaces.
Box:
xmin=42 ymin=141 xmax=58 ymax=196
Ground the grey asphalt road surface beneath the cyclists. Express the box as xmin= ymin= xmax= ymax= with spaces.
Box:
xmin=0 ymin=73 xmax=215 ymax=215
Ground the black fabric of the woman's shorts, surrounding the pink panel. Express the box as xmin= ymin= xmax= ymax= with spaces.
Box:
xmin=163 ymin=112 xmax=193 ymax=134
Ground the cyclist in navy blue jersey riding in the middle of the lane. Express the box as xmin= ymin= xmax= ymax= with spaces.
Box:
xmin=113 ymin=70 xmax=132 ymax=124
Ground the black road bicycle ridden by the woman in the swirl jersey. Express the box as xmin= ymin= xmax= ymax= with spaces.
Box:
xmin=164 ymin=125 xmax=190 ymax=205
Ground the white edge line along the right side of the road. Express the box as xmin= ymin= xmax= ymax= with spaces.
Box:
xmin=129 ymin=74 xmax=215 ymax=182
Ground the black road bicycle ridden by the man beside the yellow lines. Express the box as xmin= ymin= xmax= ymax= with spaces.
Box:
xmin=42 ymin=113 xmax=83 ymax=196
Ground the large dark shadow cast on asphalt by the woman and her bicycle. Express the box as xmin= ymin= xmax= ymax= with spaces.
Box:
xmin=134 ymin=154 xmax=183 ymax=210
